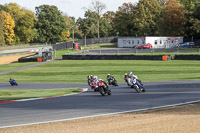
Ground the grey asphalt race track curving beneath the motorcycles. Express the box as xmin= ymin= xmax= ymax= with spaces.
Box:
xmin=0 ymin=81 xmax=200 ymax=128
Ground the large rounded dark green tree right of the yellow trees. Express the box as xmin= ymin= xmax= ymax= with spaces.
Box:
xmin=36 ymin=5 xmax=66 ymax=43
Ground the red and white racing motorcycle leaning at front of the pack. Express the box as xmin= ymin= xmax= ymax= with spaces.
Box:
xmin=90 ymin=80 xmax=111 ymax=96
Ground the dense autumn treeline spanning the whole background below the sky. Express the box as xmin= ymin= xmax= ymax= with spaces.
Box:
xmin=0 ymin=0 xmax=200 ymax=45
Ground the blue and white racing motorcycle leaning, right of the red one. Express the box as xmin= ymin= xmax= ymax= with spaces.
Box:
xmin=130 ymin=78 xmax=145 ymax=93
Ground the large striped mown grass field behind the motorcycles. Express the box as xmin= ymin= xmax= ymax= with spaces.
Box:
xmin=0 ymin=60 xmax=200 ymax=83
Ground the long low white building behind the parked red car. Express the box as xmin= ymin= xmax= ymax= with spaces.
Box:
xmin=118 ymin=36 xmax=183 ymax=48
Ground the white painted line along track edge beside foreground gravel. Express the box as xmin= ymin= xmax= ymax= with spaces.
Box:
xmin=0 ymin=100 xmax=200 ymax=129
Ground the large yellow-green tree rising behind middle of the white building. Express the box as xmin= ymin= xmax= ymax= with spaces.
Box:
xmin=134 ymin=0 xmax=162 ymax=36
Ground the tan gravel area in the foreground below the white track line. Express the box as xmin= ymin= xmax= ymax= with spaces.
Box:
xmin=0 ymin=103 xmax=200 ymax=133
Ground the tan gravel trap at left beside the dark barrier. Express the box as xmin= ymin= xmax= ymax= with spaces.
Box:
xmin=0 ymin=54 xmax=32 ymax=65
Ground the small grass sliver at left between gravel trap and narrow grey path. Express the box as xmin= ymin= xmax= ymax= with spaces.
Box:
xmin=0 ymin=62 xmax=38 ymax=72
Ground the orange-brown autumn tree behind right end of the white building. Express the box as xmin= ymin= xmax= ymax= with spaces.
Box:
xmin=163 ymin=0 xmax=185 ymax=36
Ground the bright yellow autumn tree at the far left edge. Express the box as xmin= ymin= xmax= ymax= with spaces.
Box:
xmin=2 ymin=11 xmax=15 ymax=45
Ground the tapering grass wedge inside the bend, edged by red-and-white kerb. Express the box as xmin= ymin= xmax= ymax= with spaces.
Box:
xmin=0 ymin=88 xmax=82 ymax=101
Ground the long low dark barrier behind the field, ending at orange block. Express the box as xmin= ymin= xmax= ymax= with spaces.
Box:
xmin=62 ymin=55 xmax=171 ymax=60
